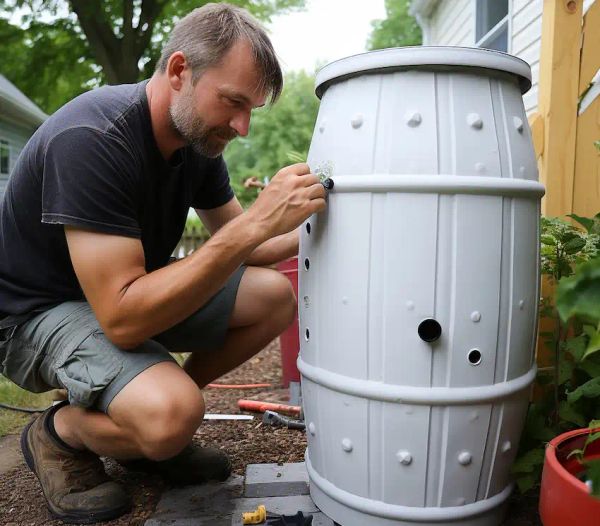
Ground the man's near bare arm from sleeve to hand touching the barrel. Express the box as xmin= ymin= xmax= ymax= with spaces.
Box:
xmin=65 ymin=165 xmax=325 ymax=348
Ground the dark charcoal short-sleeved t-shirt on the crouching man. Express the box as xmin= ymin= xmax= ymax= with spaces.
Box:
xmin=0 ymin=81 xmax=233 ymax=326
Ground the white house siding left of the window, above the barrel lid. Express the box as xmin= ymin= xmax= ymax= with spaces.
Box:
xmin=430 ymin=0 xmax=475 ymax=46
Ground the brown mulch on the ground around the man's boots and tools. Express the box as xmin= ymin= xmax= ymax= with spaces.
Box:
xmin=0 ymin=341 xmax=306 ymax=526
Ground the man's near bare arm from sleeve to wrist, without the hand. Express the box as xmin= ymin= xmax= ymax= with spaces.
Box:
xmin=65 ymin=214 xmax=262 ymax=349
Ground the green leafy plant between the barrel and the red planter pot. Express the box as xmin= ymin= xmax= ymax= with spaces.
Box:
xmin=513 ymin=214 xmax=600 ymax=492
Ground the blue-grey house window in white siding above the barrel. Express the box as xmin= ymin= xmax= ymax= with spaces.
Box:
xmin=475 ymin=0 xmax=508 ymax=52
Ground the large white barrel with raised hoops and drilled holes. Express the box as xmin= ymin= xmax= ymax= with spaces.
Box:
xmin=298 ymin=47 xmax=544 ymax=526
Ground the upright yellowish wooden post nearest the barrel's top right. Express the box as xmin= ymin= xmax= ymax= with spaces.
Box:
xmin=538 ymin=0 xmax=583 ymax=217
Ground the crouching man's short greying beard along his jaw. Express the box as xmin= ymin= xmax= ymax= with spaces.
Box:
xmin=169 ymin=86 xmax=237 ymax=157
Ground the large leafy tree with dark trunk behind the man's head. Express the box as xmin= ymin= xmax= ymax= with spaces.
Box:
xmin=0 ymin=0 xmax=305 ymax=113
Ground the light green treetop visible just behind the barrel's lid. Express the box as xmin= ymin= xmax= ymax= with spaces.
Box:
xmin=367 ymin=0 xmax=423 ymax=50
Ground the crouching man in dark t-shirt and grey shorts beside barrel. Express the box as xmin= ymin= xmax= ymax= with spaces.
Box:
xmin=0 ymin=4 xmax=325 ymax=523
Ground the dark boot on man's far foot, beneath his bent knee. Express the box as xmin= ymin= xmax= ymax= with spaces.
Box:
xmin=117 ymin=444 xmax=231 ymax=486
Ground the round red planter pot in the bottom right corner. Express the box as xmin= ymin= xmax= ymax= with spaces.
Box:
xmin=540 ymin=429 xmax=600 ymax=526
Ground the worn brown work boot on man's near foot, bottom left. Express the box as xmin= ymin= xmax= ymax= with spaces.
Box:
xmin=21 ymin=404 xmax=131 ymax=524
